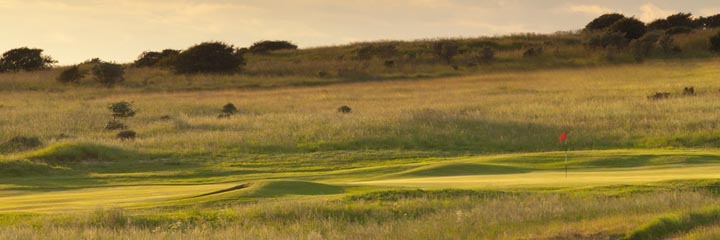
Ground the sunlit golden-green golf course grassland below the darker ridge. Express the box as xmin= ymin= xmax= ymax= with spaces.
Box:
xmin=0 ymin=55 xmax=720 ymax=239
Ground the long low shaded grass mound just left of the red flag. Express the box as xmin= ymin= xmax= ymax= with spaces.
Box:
xmin=396 ymin=163 xmax=530 ymax=177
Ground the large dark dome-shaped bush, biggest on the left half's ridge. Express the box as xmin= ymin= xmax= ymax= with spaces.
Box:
xmin=174 ymin=42 xmax=245 ymax=74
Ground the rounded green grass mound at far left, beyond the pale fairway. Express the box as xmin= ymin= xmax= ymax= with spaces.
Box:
xmin=27 ymin=143 xmax=140 ymax=163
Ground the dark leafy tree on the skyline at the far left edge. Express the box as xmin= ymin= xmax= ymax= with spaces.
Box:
xmin=0 ymin=47 xmax=57 ymax=72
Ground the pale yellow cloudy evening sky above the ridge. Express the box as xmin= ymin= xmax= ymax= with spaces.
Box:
xmin=0 ymin=0 xmax=720 ymax=65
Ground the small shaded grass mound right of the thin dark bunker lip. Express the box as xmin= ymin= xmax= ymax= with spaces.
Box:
xmin=247 ymin=180 xmax=345 ymax=197
